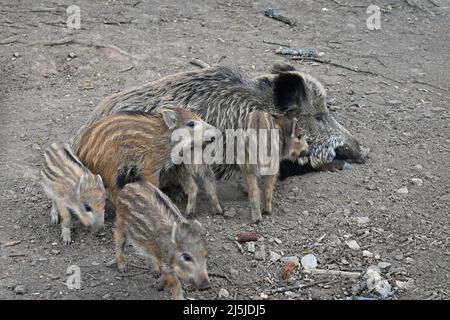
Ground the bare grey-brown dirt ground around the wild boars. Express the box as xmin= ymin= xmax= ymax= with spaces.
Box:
xmin=0 ymin=0 xmax=450 ymax=299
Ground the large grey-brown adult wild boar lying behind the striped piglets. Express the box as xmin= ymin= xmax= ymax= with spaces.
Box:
xmin=72 ymin=65 xmax=366 ymax=176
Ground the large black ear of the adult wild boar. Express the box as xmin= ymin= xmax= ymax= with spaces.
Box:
xmin=273 ymin=72 xmax=306 ymax=114
